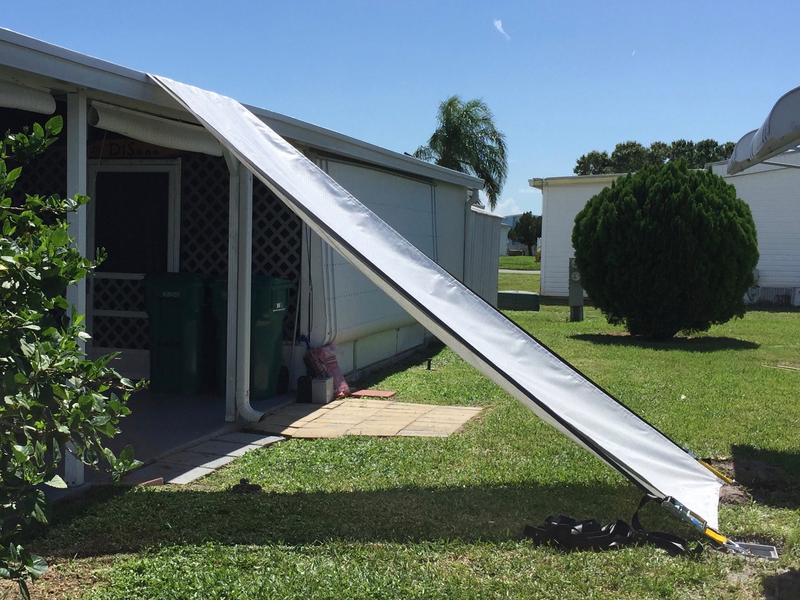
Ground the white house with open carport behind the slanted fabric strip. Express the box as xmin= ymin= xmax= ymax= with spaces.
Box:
xmin=0 ymin=29 xmax=499 ymax=436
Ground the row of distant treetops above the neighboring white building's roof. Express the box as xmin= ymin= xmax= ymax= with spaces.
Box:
xmin=573 ymin=139 xmax=734 ymax=175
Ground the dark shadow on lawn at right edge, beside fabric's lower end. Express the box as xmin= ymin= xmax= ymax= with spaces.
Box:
xmin=732 ymin=445 xmax=800 ymax=508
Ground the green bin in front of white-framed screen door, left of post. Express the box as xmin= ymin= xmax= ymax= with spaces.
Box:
xmin=145 ymin=273 xmax=205 ymax=394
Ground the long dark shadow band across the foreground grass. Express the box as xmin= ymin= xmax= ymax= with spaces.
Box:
xmin=32 ymin=484 xmax=652 ymax=557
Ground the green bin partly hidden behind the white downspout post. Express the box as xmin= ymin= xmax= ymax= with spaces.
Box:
xmin=210 ymin=276 xmax=293 ymax=400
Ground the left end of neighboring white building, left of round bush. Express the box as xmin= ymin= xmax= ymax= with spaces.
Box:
xmin=529 ymin=175 xmax=620 ymax=298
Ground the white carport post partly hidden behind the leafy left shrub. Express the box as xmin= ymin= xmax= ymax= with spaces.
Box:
xmin=64 ymin=91 xmax=87 ymax=487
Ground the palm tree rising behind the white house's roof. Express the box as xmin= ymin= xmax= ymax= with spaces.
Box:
xmin=414 ymin=96 xmax=508 ymax=208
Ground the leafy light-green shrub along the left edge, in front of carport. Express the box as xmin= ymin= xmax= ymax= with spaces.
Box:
xmin=0 ymin=117 xmax=139 ymax=598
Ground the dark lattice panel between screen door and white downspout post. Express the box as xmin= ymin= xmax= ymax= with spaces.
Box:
xmin=180 ymin=153 xmax=228 ymax=277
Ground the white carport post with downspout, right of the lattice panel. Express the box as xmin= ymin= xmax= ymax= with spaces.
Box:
xmin=225 ymin=153 xmax=263 ymax=422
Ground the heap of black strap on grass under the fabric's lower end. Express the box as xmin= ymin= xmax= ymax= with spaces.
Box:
xmin=523 ymin=495 xmax=703 ymax=556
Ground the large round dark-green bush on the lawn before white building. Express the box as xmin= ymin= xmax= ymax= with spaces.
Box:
xmin=572 ymin=160 xmax=758 ymax=339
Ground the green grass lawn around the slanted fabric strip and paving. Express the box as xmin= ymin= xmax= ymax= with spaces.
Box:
xmin=21 ymin=306 xmax=800 ymax=599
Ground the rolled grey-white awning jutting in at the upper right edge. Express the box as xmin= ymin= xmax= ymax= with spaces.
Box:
xmin=727 ymin=87 xmax=800 ymax=175
